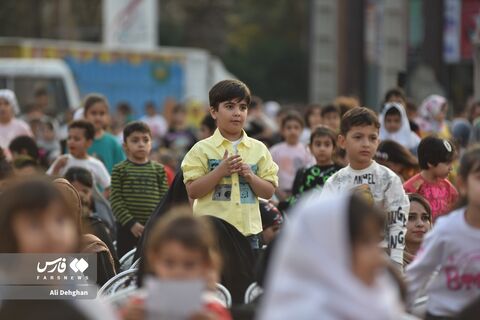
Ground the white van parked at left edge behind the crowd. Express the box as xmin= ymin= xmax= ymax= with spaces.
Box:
xmin=0 ymin=58 xmax=80 ymax=115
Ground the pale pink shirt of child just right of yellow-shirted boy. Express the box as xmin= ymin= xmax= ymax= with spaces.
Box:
xmin=270 ymin=142 xmax=315 ymax=191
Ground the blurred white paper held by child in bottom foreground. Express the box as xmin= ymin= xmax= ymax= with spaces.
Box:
xmin=145 ymin=278 xmax=206 ymax=320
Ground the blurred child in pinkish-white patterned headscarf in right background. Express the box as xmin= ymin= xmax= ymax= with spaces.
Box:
xmin=415 ymin=94 xmax=452 ymax=139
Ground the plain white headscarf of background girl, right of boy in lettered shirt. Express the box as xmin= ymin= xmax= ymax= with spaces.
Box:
xmin=379 ymin=102 xmax=420 ymax=154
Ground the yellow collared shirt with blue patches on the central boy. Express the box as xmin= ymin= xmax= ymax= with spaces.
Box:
xmin=182 ymin=129 xmax=278 ymax=236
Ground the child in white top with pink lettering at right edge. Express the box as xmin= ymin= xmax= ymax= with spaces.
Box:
xmin=406 ymin=147 xmax=480 ymax=319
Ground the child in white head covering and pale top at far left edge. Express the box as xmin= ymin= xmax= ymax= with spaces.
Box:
xmin=0 ymin=89 xmax=33 ymax=158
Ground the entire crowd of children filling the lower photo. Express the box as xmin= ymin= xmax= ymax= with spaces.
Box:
xmin=0 ymin=80 xmax=480 ymax=320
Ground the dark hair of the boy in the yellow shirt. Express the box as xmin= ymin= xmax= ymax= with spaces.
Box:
xmin=208 ymin=79 xmax=252 ymax=111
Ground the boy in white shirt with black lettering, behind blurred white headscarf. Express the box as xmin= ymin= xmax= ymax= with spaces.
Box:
xmin=322 ymin=107 xmax=410 ymax=269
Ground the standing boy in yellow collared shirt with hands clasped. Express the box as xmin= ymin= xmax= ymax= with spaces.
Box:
xmin=182 ymin=80 xmax=278 ymax=248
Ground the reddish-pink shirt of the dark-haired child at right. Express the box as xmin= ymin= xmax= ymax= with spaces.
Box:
xmin=403 ymin=173 xmax=458 ymax=222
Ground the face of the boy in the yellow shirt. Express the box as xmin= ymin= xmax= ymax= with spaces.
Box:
xmin=210 ymin=99 xmax=248 ymax=136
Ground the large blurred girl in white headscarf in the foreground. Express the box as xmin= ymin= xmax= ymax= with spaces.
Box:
xmin=259 ymin=193 xmax=402 ymax=320
